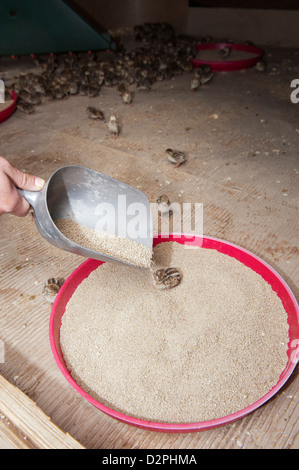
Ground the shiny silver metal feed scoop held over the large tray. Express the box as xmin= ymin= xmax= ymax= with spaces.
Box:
xmin=18 ymin=165 xmax=153 ymax=264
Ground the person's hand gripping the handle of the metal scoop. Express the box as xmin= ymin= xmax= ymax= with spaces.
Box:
xmin=0 ymin=157 xmax=45 ymax=217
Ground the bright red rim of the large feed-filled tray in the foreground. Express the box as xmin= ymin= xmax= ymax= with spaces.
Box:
xmin=49 ymin=234 xmax=299 ymax=433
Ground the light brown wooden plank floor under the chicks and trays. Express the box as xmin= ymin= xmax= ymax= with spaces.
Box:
xmin=0 ymin=46 xmax=299 ymax=449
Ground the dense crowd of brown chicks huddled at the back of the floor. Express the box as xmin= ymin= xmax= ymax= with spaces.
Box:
xmin=9 ymin=23 xmax=202 ymax=114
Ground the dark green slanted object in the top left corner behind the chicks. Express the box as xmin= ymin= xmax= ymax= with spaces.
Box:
xmin=0 ymin=0 xmax=114 ymax=55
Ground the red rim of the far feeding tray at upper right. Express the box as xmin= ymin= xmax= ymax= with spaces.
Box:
xmin=191 ymin=42 xmax=264 ymax=72
